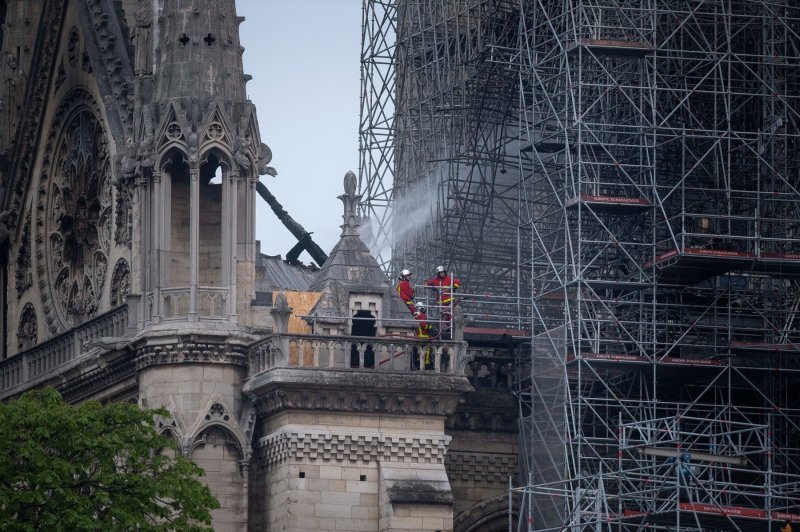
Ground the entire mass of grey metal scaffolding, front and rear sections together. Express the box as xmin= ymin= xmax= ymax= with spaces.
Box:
xmin=361 ymin=0 xmax=800 ymax=530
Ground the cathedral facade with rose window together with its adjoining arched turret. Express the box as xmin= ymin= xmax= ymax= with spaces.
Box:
xmin=0 ymin=0 xmax=274 ymax=530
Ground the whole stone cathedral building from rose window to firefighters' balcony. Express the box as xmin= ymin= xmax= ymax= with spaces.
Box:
xmin=0 ymin=0 xmax=518 ymax=532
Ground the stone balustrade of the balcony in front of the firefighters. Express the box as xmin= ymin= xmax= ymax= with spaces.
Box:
xmin=249 ymin=334 xmax=466 ymax=377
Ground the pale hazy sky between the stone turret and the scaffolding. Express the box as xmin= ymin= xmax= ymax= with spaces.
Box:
xmin=236 ymin=0 xmax=361 ymax=262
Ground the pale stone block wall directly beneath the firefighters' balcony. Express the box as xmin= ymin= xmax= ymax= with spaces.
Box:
xmin=258 ymin=412 xmax=453 ymax=532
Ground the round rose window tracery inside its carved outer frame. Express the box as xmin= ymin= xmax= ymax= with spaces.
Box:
xmin=46 ymin=107 xmax=113 ymax=323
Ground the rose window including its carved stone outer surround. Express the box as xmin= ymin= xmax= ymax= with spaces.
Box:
xmin=36 ymin=89 xmax=114 ymax=333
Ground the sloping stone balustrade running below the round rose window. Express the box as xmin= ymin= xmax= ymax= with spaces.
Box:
xmin=0 ymin=305 xmax=128 ymax=398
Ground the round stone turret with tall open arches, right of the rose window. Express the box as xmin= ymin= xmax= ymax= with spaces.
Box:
xmin=120 ymin=0 xmax=270 ymax=529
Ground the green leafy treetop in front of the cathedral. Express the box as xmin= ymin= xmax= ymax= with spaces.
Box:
xmin=0 ymin=388 xmax=219 ymax=531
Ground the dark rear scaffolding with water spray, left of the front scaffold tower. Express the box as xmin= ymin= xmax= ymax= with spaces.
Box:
xmin=361 ymin=0 xmax=521 ymax=295
